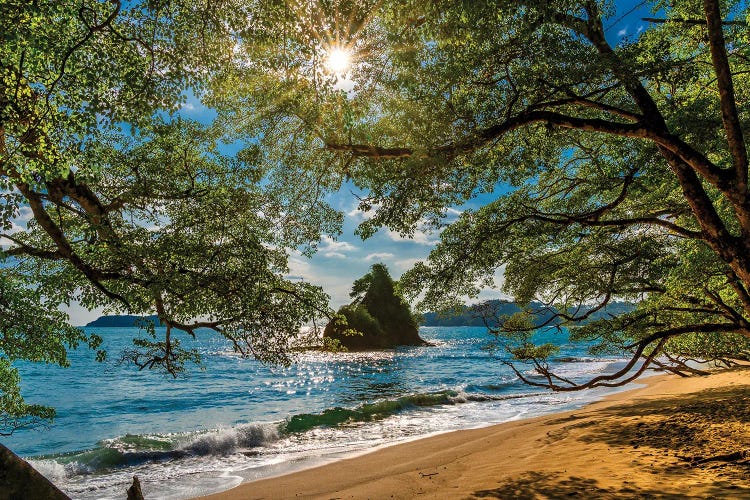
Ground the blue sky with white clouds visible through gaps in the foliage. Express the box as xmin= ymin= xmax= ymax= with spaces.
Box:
xmin=8 ymin=0 xmax=651 ymax=325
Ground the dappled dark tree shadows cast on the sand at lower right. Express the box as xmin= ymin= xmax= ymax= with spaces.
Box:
xmin=470 ymin=385 xmax=750 ymax=500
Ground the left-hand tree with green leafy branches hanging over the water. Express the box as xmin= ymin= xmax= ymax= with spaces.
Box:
xmin=0 ymin=0 xmax=341 ymax=432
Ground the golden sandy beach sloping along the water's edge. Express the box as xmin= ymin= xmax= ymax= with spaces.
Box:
xmin=205 ymin=367 xmax=750 ymax=500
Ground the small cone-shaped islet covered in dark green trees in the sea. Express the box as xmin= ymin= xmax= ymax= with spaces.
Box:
xmin=324 ymin=264 xmax=425 ymax=349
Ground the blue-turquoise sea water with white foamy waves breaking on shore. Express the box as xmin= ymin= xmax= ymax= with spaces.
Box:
xmin=2 ymin=327 xmax=619 ymax=499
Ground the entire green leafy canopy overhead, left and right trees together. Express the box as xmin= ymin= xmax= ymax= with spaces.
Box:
xmin=0 ymin=0 xmax=750 ymax=432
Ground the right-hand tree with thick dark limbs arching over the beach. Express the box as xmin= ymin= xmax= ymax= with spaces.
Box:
xmin=229 ymin=0 xmax=750 ymax=390
